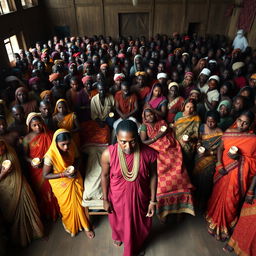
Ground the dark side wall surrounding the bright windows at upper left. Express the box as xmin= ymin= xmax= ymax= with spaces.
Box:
xmin=0 ymin=0 xmax=48 ymax=67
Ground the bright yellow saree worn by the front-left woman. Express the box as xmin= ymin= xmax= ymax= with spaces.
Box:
xmin=45 ymin=129 xmax=90 ymax=236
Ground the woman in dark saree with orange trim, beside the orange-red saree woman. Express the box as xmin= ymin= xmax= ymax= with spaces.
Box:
xmin=193 ymin=111 xmax=223 ymax=211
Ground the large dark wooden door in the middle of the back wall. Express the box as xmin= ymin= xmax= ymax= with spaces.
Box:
xmin=119 ymin=12 xmax=149 ymax=38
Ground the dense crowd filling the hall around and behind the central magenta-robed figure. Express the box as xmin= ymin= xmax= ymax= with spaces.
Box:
xmin=0 ymin=33 xmax=256 ymax=255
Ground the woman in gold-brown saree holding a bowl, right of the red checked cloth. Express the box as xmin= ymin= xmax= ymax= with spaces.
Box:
xmin=174 ymin=99 xmax=200 ymax=172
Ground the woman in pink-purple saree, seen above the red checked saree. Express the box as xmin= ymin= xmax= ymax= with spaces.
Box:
xmin=144 ymin=83 xmax=167 ymax=120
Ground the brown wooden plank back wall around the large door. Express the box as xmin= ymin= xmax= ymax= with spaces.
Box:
xmin=44 ymin=0 xmax=234 ymax=38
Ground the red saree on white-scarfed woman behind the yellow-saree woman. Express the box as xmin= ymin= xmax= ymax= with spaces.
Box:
xmin=28 ymin=132 xmax=59 ymax=220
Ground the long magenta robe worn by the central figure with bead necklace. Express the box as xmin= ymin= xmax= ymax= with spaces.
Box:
xmin=108 ymin=144 xmax=157 ymax=256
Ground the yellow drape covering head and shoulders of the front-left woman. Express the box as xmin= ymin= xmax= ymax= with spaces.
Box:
xmin=45 ymin=129 xmax=75 ymax=173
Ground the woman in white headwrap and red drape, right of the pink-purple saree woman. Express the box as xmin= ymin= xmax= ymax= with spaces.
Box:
xmin=167 ymin=82 xmax=184 ymax=123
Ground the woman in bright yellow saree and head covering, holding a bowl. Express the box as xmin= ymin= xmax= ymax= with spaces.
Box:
xmin=43 ymin=129 xmax=94 ymax=238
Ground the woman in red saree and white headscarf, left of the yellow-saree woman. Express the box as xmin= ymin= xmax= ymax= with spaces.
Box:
xmin=23 ymin=112 xmax=59 ymax=221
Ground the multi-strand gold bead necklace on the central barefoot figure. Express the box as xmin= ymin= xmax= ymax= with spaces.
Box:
xmin=118 ymin=145 xmax=140 ymax=182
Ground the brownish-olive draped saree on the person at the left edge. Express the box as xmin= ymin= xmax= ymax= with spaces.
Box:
xmin=0 ymin=140 xmax=43 ymax=246
